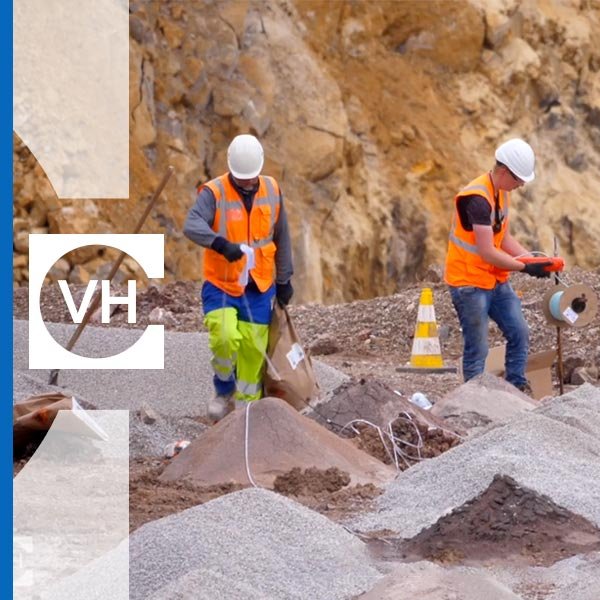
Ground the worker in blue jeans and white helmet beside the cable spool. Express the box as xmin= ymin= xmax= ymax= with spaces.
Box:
xmin=445 ymin=138 xmax=551 ymax=392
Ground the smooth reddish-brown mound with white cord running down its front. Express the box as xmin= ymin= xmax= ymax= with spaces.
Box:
xmin=161 ymin=398 xmax=395 ymax=487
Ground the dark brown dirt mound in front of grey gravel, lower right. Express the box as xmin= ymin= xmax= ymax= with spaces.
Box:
xmin=373 ymin=475 xmax=600 ymax=566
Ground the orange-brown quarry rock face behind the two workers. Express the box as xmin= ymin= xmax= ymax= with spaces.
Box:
xmin=14 ymin=0 xmax=600 ymax=302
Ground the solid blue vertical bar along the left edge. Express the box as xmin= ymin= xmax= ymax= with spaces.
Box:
xmin=0 ymin=2 xmax=13 ymax=598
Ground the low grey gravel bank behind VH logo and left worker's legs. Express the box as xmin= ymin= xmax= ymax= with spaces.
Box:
xmin=14 ymin=320 xmax=348 ymax=417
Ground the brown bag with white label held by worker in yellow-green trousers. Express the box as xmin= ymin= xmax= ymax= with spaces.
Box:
xmin=263 ymin=303 xmax=319 ymax=410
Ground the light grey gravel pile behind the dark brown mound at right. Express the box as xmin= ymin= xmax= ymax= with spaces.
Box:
xmin=352 ymin=385 xmax=600 ymax=538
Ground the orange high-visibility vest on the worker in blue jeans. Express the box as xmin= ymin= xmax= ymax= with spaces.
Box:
xmin=444 ymin=173 xmax=510 ymax=290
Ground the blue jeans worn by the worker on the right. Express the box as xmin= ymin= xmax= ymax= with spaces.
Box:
xmin=450 ymin=282 xmax=529 ymax=387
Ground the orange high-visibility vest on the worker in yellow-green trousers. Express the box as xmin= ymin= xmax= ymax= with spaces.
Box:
xmin=203 ymin=173 xmax=281 ymax=296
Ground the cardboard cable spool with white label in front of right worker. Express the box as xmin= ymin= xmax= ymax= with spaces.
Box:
xmin=542 ymin=284 xmax=598 ymax=327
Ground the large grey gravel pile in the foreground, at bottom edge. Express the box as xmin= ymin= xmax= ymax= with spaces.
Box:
xmin=44 ymin=489 xmax=382 ymax=600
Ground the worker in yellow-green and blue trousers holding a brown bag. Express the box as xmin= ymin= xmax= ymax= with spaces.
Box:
xmin=183 ymin=134 xmax=294 ymax=422
